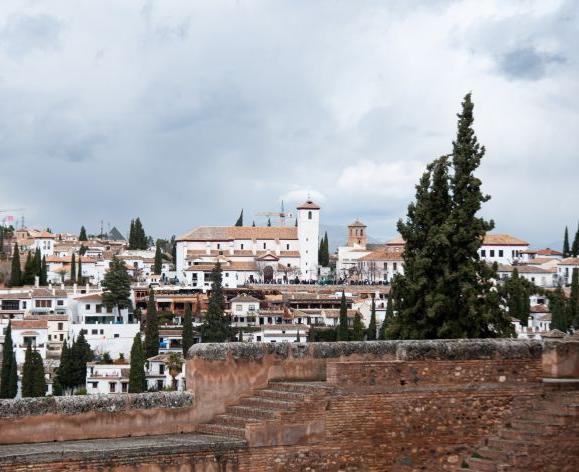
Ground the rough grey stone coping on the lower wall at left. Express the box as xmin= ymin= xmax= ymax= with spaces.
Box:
xmin=0 ymin=392 xmax=194 ymax=418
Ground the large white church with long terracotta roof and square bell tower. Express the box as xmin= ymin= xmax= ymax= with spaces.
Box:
xmin=176 ymin=200 xmax=320 ymax=289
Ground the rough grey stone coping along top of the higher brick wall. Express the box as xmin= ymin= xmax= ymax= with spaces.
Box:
xmin=187 ymin=339 xmax=545 ymax=361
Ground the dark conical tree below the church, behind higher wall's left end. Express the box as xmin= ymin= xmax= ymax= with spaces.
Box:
xmin=201 ymin=262 xmax=231 ymax=343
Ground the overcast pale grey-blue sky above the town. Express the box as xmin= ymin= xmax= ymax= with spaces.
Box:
xmin=0 ymin=0 xmax=579 ymax=246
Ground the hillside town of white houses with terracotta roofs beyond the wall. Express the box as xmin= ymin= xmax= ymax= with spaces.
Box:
xmin=0 ymin=199 xmax=579 ymax=396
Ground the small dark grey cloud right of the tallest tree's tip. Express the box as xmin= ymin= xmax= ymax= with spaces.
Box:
xmin=498 ymin=47 xmax=565 ymax=80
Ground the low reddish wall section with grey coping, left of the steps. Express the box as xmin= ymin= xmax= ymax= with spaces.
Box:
xmin=0 ymin=392 xmax=198 ymax=444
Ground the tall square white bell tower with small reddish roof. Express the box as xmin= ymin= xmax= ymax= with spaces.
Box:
xmin=297 ymin=197 xmax=320 ymax=280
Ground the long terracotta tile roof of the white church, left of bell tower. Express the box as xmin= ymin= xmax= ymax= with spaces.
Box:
xmin=177 ymin=226 xmax=298 ymax=241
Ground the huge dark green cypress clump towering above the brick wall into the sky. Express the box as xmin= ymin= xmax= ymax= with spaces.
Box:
xmin=388 ymin=94 xmax=512 ymax=339
